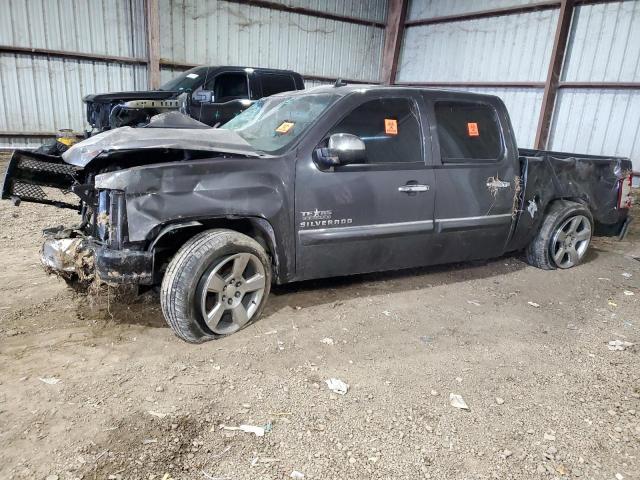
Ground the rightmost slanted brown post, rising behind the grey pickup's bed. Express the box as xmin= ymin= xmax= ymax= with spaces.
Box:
xmin=535 ymin=0 xmax=574 ymax=150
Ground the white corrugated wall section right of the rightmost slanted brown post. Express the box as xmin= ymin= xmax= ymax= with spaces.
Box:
xmin=549 ymin=1 xmax=640 ymax=167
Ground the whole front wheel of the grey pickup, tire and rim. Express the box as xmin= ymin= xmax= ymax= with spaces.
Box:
xmin=160 ymin=229 xmax=271 ymax=343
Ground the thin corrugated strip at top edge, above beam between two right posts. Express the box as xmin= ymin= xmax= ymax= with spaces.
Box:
xmin=407 ymin=0 xmax=538 ymax=20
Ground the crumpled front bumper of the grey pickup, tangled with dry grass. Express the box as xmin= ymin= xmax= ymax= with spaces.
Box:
xmin=40 ymin=237 xmax=153 ymax=285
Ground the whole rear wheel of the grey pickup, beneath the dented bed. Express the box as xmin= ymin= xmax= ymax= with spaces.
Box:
xmin=525 ymin=200 xmax=593 ymax=270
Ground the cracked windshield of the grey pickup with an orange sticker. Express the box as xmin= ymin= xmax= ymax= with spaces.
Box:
xmin=220 ymin=93 xmax=338 ymax=153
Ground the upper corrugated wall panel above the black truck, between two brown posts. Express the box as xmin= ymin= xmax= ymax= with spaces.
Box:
xmin=160 ymin=0 xmax=384 ymax=81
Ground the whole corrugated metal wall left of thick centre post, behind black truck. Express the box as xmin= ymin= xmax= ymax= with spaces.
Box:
xmin=0 ymin=0 xmax=387 ymax=148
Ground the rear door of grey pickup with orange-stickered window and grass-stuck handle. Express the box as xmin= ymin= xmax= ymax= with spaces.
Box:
xmin=427 ymin=94 xmax=519 ymax=262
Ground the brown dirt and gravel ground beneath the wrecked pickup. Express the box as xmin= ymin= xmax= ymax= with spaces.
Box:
xmin=0 ymin=155 xmax=640 ymax=480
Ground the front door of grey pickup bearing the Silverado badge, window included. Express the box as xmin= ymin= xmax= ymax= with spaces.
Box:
xmin=295 ymin=92 xmax=435 ymax=279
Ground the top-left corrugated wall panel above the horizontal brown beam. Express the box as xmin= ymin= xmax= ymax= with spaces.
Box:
xmin=0 ymin=0 xmax=147 ymax=58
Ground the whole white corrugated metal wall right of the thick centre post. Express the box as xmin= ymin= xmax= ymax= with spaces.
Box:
xmin=397 ymin=0 xmax=640 ymax=170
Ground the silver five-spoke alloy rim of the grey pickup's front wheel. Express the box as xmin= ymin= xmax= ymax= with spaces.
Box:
xmin=200 ymin=253 xmax=266 ymax=335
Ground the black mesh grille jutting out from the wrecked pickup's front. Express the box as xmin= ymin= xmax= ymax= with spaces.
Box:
xmin=2 ymin=150 xmax=80 ymax=210
